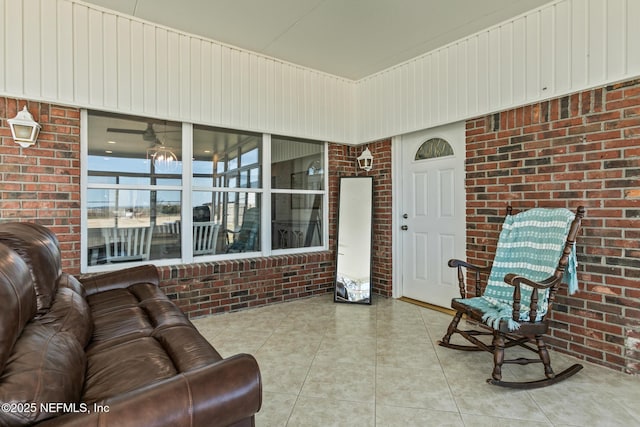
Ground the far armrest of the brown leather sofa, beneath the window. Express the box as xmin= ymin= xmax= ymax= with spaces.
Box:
xmin=79 ymin=265 xmax=160 ymax=295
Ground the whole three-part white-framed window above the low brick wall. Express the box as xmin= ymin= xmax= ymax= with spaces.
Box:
xmin=83 ymin=111 xmax=327 ymax=271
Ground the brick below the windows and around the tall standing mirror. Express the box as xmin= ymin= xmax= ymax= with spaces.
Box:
xmin=160 ymin=140 xmax=392 ymax=316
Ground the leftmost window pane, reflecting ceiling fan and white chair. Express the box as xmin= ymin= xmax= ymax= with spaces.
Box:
xmin=86 ymin=112 xmax=182 ymax=266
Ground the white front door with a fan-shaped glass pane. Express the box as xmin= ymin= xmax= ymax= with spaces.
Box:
xmin=400 ymin=122 xmax=466 ymax=307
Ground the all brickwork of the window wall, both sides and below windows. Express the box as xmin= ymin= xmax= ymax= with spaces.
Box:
xmin=0 ymin=98 xmax=391 ymax=316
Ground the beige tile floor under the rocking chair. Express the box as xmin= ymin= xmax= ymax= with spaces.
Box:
xmin=194 ymin=296 xmax=640 ymax=427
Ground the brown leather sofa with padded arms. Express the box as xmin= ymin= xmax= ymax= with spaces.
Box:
xmin=0 ymin=223 xmax=262 ymax=427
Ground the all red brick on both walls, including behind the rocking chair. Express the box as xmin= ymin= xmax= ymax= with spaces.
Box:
xmin=5 ymin=84 xmax=640 ymax=373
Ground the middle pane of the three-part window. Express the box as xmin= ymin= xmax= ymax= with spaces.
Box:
xmin=192 ymin=126 xmax=262 ymax=256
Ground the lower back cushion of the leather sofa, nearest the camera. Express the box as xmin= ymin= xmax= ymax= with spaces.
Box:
xmin=0 ymin=322 xmax=86 ymax=426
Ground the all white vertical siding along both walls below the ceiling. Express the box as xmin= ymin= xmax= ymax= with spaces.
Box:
xmin=0 ymin=0 xmax=640 ymax=143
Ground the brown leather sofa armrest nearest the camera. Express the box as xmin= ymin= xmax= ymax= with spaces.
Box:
xmin=34 ymin=354 xmax=262 ymax=427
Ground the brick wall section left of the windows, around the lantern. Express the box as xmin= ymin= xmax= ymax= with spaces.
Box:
xmin=0 ymin=97 xmax=80 ymax=274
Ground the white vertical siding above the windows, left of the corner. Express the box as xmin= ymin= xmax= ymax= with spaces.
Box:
xmin=0 ymin=0 xmax=356 ymax=142
